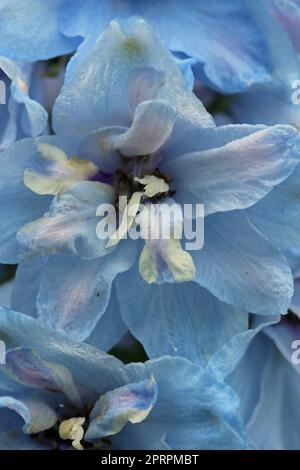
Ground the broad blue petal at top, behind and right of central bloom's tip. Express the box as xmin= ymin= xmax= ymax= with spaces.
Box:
xmin=61 ymin=0 xmax=271 ymax=93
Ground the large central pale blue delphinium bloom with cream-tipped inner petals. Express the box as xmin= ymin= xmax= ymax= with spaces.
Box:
xmin=1 ymin=18 xmax=299 ymax=355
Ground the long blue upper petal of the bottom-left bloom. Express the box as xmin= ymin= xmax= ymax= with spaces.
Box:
xmin=0 ymin=308 xmax=128 ymax=399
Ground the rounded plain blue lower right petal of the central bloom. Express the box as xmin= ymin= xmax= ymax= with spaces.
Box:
xmin=191 ymin=211 xmax=293 ymax=315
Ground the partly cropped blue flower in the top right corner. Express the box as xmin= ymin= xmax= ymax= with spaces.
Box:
xmin=234 ymin=0 xmax=300 ymax=127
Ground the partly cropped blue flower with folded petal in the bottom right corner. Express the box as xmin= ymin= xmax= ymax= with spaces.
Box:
xmin=199 ymin=249 xmax=300 ymax=450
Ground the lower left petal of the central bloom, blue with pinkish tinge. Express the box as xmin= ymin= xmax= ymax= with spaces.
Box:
xmin=37 ymin=240 xmax=136 ymax=341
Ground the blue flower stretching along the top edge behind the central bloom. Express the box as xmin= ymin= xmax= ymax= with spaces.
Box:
xmin=0 ymin=0 xmax=272 ymax=92
